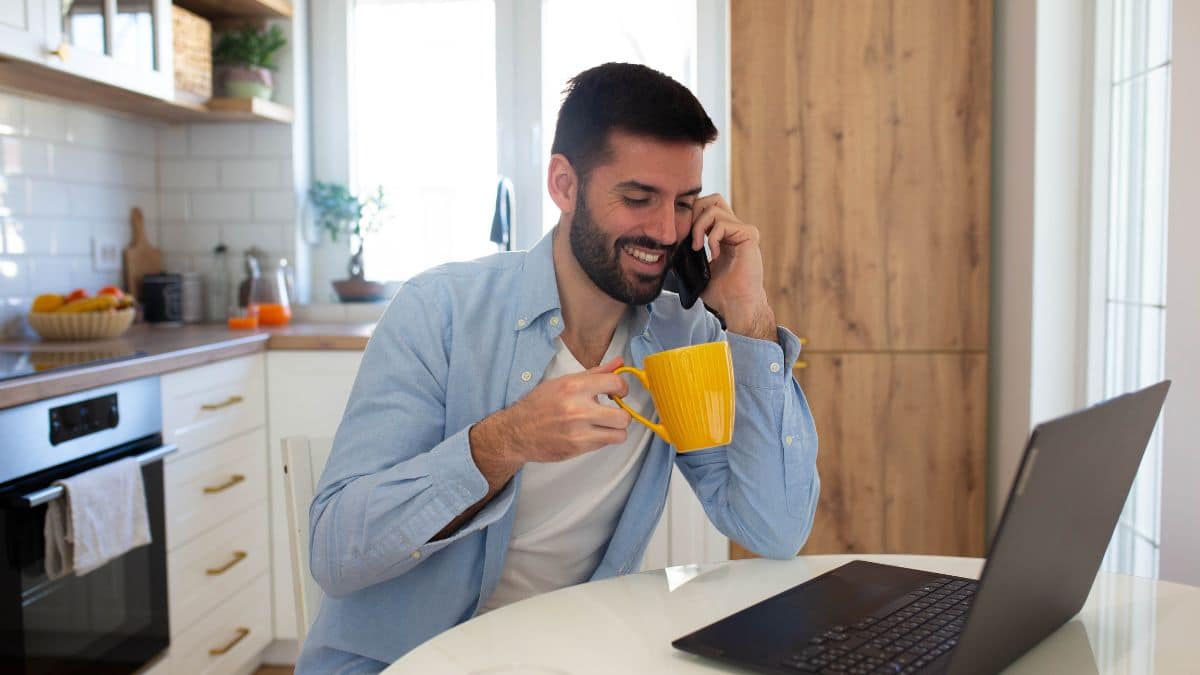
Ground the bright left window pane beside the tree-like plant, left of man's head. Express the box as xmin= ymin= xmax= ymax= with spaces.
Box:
xmin=349 ymin=0 xmax=497 ymax=280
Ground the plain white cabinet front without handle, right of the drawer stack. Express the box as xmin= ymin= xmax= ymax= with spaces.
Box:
xmin=266 ymin=351 xmax=362 ymax=640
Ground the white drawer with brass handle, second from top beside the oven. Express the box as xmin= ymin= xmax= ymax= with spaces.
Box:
xmin=164 ymin=429 xmax=266 ymax=550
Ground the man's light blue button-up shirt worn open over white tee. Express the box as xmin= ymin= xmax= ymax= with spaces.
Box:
xmin=298 ymin=229 xmax=820 ymax=673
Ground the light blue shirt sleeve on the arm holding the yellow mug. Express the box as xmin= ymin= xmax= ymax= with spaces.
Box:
xmin=310 ymin=282 xmax=512 ymax=597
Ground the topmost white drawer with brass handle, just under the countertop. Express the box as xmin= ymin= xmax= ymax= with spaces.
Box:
xmin=162 ymin=354 xmax=266 ymax=461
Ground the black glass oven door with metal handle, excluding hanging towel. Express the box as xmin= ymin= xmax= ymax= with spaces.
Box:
xmin=0 ymin=435 xmax=174 ymax=674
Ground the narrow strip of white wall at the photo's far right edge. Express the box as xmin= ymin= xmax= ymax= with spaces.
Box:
xmin=1159 ymin=0 xmax=1200 ymax=586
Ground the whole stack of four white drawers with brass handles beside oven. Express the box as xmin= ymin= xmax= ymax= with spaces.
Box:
xmin=161 ymin=354 xmax=271 ymax=675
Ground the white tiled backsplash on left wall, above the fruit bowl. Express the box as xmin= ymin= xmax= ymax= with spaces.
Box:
xmin=0 ymin=90 xmax=158 ymax=338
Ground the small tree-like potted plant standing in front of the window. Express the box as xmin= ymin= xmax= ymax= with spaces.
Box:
xmin=308 ymin=180 xmax=386 ymax=303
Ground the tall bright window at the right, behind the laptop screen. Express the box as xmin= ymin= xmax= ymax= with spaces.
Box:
xmin=1088 ymin=0 xmax=1171 ymax=577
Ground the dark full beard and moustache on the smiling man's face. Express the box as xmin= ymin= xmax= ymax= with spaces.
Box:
xmin=570 ymin=186 xmax=674 ymax=305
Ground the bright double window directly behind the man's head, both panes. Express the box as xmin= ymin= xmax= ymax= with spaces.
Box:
xmin=345 ymin=0 xmax=700 ymax=280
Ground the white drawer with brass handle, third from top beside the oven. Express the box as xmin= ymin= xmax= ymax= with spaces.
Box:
xmin=167 ymin=502 xmax=270 ymax=635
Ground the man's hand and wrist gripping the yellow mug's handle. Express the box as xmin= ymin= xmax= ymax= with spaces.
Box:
xmin=470 ymin=357 xmax=631 ymax=490
